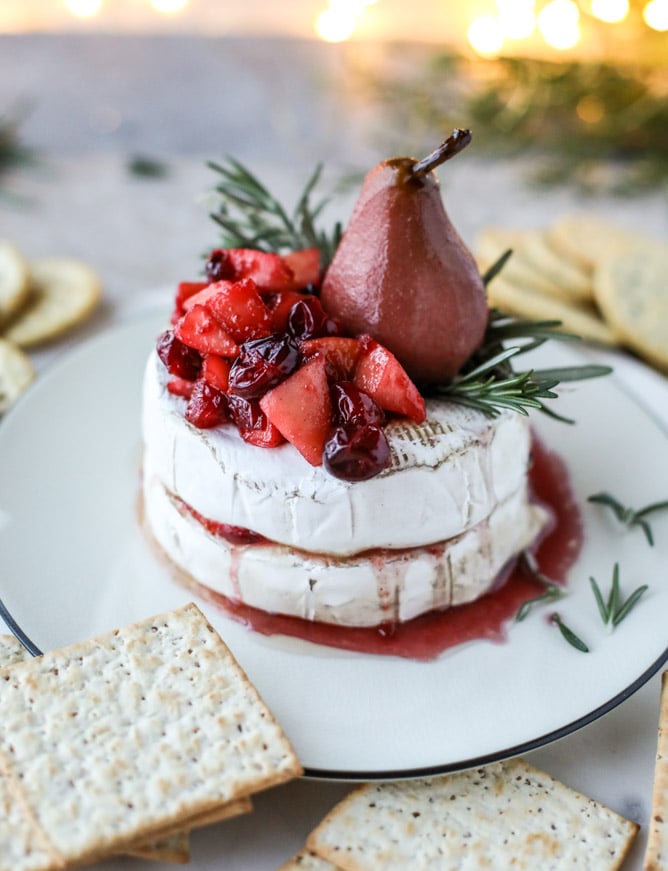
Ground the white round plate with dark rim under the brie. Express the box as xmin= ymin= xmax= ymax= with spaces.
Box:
xmin=0 ymin=313 xmax=668 ymax=779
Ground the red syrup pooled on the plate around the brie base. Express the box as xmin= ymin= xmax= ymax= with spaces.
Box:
xmin=189 ymin=439 xmax=583 ymax=660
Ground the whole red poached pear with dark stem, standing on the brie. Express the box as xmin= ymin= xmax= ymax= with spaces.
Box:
xmin=321 ymin=130 xmax=488 ymax=384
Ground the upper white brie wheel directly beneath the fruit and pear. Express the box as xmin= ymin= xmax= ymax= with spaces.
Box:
xmin=143 ymin=353 xmax=531 ymax=560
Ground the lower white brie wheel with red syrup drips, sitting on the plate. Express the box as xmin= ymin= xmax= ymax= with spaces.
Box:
xmin=144 ymin=458 xmax=547 ymax=627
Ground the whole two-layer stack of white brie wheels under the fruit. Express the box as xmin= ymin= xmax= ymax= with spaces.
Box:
xmin=143 ymin=354 xmax=548 ymax=626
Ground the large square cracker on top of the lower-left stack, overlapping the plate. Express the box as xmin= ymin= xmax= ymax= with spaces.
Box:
xmin=0 ymin=604 xmax=301 ymax=871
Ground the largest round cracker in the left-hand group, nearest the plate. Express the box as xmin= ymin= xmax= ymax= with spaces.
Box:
xmin=5 ymin=257 xmax=102 ymax=348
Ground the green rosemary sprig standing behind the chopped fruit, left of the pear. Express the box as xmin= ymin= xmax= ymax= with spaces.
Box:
xmin=208 ymin=158 xmax=342 ymax=268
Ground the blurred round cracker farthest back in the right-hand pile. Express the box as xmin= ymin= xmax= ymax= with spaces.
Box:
xmin=547 ymin=212 xmax=642 ymax=271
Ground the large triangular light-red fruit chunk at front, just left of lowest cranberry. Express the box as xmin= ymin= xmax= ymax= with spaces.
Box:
xmin=260 ymin=357 xmax=332 ymax=466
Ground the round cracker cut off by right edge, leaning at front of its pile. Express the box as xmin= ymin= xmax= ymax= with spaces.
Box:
xmin=594 ymin=239 xmax=668 ymax=371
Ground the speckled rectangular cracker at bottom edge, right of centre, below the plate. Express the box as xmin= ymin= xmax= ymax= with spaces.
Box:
xmin=306 ymin=759 xmax=638 ymax=871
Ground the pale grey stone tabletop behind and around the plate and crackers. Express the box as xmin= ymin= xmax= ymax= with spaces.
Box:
xmin=0 ymin=36 xmax=668 ymax=871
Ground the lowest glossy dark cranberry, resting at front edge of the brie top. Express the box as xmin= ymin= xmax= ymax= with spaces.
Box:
xmin=323 ymin=424 xmax=391 ymax=481
